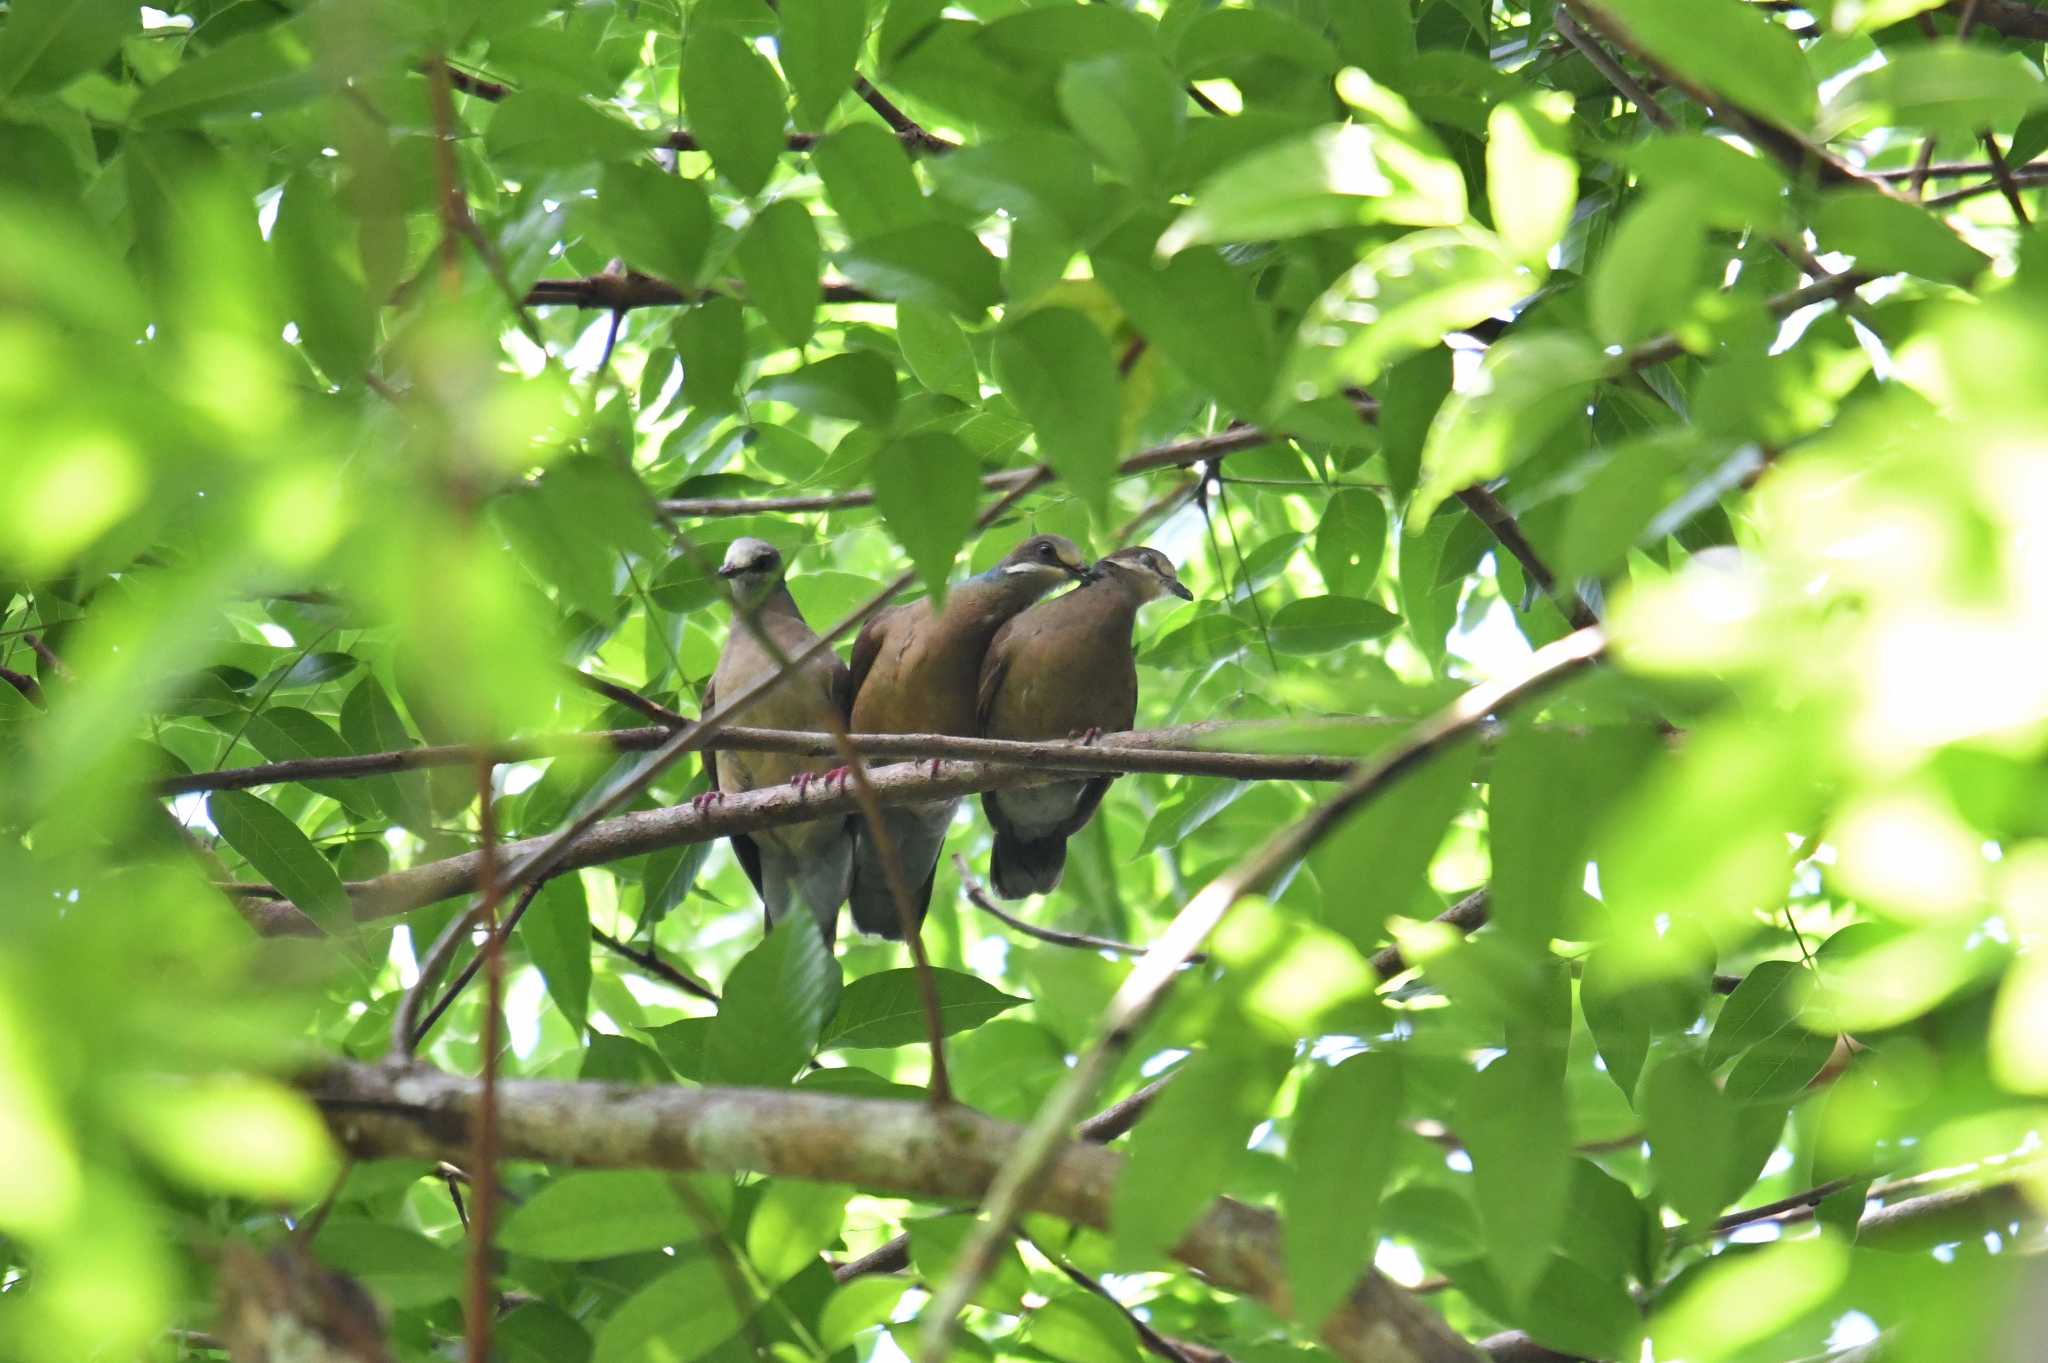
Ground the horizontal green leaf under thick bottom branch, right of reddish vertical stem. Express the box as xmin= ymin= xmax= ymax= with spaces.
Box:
xmin=498 ymin=1162 xmax=719 ymax=1261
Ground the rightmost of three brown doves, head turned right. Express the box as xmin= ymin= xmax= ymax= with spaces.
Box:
xmin=977 ymin=546 xmax=1194 ymax=898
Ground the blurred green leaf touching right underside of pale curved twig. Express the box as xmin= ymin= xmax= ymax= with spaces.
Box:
xmin=1309 ymin=743 xmax=1479 ymax=956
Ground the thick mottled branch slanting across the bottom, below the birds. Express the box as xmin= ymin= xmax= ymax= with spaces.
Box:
xmin=301 ymin=1062 xmax=1475 ymax=1363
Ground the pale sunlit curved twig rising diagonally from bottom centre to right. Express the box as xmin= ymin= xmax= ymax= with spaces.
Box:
xmin=918 ymin=628 xmax=1606 ymax=1363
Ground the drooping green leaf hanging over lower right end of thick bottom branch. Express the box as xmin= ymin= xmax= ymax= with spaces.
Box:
xmin=1280 ymin=1052 xmax=1403 ymax=1326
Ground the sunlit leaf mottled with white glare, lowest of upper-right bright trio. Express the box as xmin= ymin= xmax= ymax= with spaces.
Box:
xmin=1284 ymin=227 xmax=1536 ymax=393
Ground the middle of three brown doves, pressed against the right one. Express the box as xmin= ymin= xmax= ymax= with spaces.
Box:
xmin=848 ymin=534 xmax=1087 ymax=937
